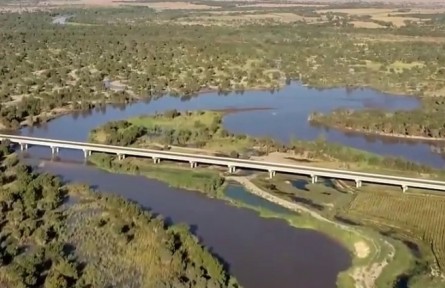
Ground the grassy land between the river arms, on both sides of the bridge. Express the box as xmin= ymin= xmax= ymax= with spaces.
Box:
xmin=90 ymin=110 xmax=445 ymax=287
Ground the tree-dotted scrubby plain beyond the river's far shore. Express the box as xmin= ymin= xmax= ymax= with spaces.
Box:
xmin=0 ymin=2 xmax=445 ymax=129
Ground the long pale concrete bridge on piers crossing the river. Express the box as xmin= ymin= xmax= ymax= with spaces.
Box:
xmin=0 ymin=134 xmax=445 ymax=192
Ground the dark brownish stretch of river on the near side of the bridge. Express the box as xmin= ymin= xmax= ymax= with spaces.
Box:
xmin=31 ymin=159 xmax=351 ymax=288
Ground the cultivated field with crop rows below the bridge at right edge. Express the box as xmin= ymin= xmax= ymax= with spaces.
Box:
xmin=346 ymin=187 xmax=445 ymax=271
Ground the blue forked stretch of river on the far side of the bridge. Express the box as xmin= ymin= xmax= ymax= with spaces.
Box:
xmin=17 ymin=82 xmax=445 ymax=168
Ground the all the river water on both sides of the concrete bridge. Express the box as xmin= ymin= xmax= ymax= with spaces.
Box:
xmin=15 ymin=83 xmax=444 ymax=288
